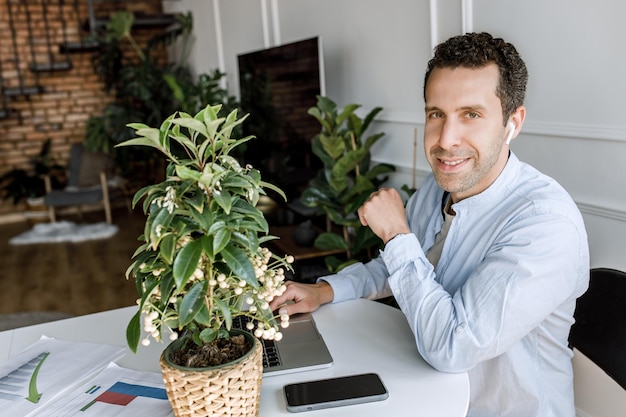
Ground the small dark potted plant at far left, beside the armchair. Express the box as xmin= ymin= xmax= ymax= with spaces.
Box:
xmin=0 ymin=139 xmax=65 ymax=221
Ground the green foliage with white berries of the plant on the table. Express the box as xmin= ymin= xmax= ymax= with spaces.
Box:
xmin=117 ymin=105 xmax=293 ymax=351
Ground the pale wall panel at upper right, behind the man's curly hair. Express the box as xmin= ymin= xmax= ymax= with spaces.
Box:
xmin=473 ymin=0 xmax=626 ymax=128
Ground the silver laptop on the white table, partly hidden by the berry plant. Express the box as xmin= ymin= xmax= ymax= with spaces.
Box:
xmin=233 ymin=313 xmax=333 ymax=377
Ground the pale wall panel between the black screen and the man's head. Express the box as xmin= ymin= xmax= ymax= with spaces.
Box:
xmin=278 ymin=0 xmax=430 ymax=117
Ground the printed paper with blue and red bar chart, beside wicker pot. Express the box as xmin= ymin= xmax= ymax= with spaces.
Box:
xmin=32 ymin=363 xmax=174 ymax=417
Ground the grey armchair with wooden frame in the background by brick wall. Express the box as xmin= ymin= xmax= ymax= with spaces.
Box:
xmin=44 ymin=144 xmax=119 ymax=224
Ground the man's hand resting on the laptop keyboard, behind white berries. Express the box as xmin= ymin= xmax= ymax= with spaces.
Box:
xmin=270 ymin=281 xmax=333 ymax=316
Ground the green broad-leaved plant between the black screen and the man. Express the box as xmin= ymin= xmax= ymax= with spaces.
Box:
xmin=301 ymin=96 xmax=395 ymax=272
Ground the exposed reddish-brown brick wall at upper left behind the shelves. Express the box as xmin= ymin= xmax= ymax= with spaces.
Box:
xmin=0 ymin=0 xmax=166 ymax=216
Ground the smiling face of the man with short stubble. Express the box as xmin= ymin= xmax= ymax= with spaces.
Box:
xmin=424 ymin=64 xmax=509 ymax=202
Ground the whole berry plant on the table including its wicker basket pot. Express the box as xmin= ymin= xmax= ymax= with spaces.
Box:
xmin=118 ymin=105 xmax=293 ymax=416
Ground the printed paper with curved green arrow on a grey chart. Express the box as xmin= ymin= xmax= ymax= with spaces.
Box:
xmin=0 ymin=336 xmax=126 ymax=417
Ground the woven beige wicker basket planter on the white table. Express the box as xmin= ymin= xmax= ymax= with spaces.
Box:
xmin=160 ymin=332 xmax=263 ymax=417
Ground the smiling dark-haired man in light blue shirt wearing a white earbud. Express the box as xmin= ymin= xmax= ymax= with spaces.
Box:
xmin=271 ymin=33 xmax=589 ymax=417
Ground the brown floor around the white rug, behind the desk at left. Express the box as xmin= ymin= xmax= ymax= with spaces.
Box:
xmin=0 ymin=208 xmax=144 ymax=315
